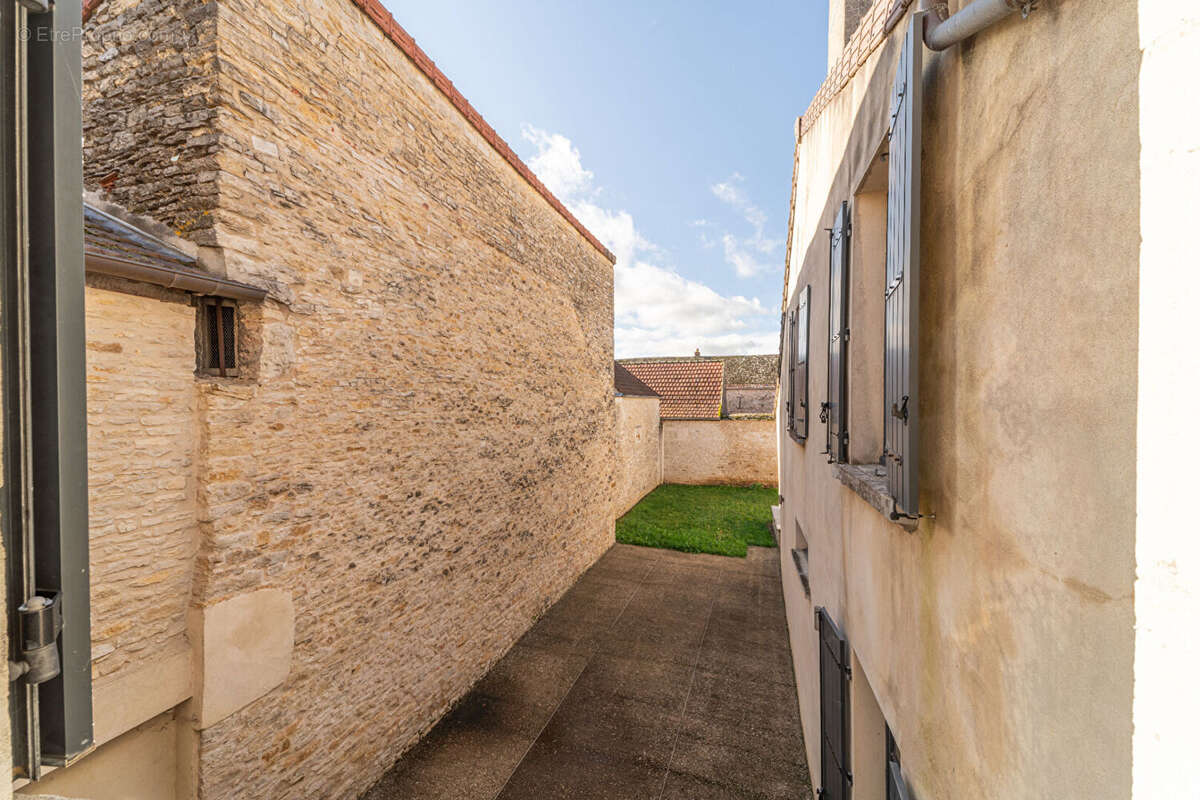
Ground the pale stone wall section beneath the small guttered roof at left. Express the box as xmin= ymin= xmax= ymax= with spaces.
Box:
xmin=85 ymin=287 xmax=199 ymax=678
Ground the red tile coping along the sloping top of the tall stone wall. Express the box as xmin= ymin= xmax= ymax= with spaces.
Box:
xmin=83 ymin=0 xmax=617 ymax=264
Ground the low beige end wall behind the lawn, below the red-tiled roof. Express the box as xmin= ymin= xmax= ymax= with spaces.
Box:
xmin=662 ymin=420 xmax=778 ymax=486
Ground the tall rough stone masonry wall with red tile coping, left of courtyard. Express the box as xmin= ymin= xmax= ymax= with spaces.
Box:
xmin=84 ymin=0 xmax=613 ymax=800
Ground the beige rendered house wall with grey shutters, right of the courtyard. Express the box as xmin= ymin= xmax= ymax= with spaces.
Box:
xmin=779 ymin=0 xmax=1140 ymax=800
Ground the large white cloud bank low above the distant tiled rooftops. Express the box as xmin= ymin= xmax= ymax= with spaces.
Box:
xmin=521 ymin=125 xmax=779 ymax=357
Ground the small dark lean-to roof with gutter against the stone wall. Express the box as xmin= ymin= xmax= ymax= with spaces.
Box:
xmin=83 ymin=201 xmax=266 ymax=300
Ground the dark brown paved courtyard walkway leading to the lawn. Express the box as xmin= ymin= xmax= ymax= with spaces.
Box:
xmin=364 ymin=545 xmax=811 ymax=800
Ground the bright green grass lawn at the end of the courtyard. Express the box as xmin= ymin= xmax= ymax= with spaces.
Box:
xmin=617 ymin=483 xmax=779 ymax=558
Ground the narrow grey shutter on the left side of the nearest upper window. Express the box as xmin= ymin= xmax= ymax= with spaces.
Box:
xmin=823 ymin=203 xmax=850 ymax=462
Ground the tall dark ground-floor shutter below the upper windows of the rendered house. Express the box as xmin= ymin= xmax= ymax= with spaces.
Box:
xmin=816 ymin=606 xmax=851 ymax=800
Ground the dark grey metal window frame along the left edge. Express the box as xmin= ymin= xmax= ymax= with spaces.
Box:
xmin=0 ymin=0 xmax=92 ymax=780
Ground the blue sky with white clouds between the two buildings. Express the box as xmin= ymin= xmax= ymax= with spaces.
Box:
xmin=384 ymin=0 xmax=827 ymax=357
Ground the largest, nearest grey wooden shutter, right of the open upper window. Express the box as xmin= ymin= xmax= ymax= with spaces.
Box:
xmin=883 ymin=17 xmax=923 ymax=518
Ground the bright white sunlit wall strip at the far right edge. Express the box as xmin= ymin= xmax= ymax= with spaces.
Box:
xmin=1133 ymin=0 xmax=1200 ymax=800
